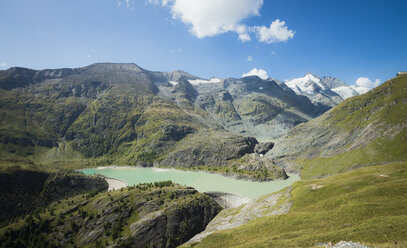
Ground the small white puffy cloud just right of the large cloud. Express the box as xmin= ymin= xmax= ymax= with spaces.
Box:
xmin=250 ymin=19 xmax=295 ymax=44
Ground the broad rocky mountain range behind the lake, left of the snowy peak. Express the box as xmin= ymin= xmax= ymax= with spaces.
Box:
xmin=0 ymin=63 xmax=332 ymax=179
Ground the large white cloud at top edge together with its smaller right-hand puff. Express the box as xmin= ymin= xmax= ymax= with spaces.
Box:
xmin=148 ymin=0 xmax=295 ymax=44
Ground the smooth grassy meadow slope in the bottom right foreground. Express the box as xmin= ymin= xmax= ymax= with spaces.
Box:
xmin=194 ymin=162 xmax=407 ymax=247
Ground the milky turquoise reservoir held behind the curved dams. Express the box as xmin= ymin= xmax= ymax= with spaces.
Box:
xmin=81 ymin=166 xmax=300 ymax=199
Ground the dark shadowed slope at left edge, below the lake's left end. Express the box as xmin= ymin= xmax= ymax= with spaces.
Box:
xmin=0 ymin=169 xmax=108 ymax=222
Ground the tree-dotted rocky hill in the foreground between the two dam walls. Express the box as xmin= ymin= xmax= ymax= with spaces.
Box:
xmin=0 ymin=181 xmax=222 ymax=247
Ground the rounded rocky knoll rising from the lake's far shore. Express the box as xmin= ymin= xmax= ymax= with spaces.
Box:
xmin=158 ymin=130 xmax=287 ymax=181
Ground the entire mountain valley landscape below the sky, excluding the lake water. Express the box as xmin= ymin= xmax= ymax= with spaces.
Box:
xmin=0 ymin=63 xmax=407 ymax=247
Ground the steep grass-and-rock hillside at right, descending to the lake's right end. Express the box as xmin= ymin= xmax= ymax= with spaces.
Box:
xmin=267 ymin=73 xmax=407 ymax=178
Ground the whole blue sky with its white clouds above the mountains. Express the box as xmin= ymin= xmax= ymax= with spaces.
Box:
xmin=0 ymin=0 xmax=407 ymax=84
